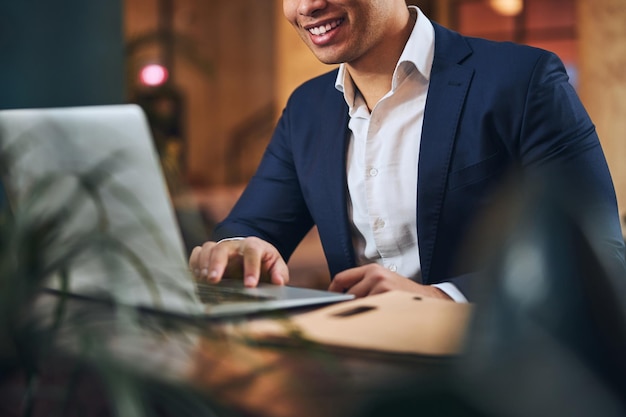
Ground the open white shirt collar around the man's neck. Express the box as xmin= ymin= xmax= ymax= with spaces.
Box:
xmin=335 ymin=6 xmax=435 ymax=108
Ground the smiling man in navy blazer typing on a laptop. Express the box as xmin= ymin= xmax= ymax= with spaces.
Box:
xmin=190 ymin=0 xmax=623 ymax=301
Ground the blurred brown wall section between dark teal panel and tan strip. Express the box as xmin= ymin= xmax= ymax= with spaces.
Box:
xmin=125 ymin=0 xmax=276 ymax=186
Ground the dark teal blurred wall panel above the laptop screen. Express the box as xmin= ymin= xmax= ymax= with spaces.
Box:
xmin=0 ymin=0 xmax=126 ymax=109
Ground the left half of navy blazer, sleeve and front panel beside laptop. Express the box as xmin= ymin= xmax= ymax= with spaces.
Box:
xmin=213 ymin=69 xmax=355 ymax=276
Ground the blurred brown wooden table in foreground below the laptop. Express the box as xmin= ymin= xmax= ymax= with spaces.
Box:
xmin=0 ymin=295 xmax=458 ymax=417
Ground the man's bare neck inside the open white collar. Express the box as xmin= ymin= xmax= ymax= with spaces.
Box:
xmin=346 ymin=9 xmax=417 ymax=110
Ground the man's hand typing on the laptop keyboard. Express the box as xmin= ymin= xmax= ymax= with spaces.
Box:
xmin=189 ymin=237 xmax=289 ymax=287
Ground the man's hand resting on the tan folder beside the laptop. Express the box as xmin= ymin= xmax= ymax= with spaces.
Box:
xmin=328 ymin=264 xmax=451 ymax=300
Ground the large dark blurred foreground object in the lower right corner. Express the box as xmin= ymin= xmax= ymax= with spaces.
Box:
xmin=354 ymin=171 xmax=626 ymax=417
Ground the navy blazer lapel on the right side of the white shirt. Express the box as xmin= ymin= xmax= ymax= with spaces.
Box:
xmin=417 ymin=24 xmax=474 ymax=284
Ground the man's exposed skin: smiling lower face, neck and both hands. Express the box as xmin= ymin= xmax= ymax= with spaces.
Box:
xmin=189 ymin=0 xmax=450 ymax=299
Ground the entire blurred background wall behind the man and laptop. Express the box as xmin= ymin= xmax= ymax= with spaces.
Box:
xmin=0 ymin=0 xmax=626 ymax=231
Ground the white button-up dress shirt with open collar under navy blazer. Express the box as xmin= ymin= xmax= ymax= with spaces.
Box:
xmin=335 ymin=6 xmax=467 ymax=301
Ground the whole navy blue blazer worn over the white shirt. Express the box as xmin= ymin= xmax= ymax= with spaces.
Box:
xmin=213 ymin=24 xmax=623 ymax=296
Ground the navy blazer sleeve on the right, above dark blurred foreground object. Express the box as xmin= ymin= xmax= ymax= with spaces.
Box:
xmin=447 ymin=51 xmax=626 ymax=300
